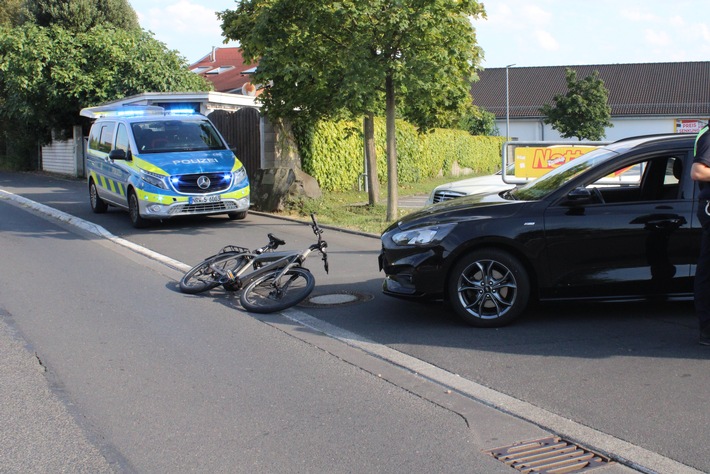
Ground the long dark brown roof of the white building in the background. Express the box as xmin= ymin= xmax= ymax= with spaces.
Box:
xmin=471 ymin=61 xmax=710 ymax=118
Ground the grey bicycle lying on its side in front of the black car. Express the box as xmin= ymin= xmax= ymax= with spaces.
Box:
xmin=180 ymin=214 xmax=328 ymax=313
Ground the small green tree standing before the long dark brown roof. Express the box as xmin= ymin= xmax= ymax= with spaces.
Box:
xmin=540 ymin=68 xmax=614 ymax=140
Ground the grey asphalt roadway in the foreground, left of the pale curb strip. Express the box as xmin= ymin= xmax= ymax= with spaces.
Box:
xmin=0 ymin=180 xmax=541 ymax=473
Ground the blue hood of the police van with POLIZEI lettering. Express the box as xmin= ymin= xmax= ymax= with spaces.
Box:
xmin=133 ymin=150 xmax=241 ymax=175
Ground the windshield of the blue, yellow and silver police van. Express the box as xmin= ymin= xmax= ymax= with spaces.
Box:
xmin=131 ymin=120 xmax=225 ymax=153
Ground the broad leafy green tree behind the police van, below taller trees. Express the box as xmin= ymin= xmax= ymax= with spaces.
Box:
xmin=0 ymin=23 xmax=209 ymax=143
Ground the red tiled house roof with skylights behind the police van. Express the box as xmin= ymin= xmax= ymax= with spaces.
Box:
xmin=190 ymin=48 xmax=256 ymax=94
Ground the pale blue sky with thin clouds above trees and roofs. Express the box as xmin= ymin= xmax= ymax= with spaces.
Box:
xmin=129 ymin=0 xmax=710 ymax=68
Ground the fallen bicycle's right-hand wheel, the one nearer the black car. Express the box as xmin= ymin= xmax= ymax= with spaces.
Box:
xmin=239 ymin=267 xmax=316 ymax=313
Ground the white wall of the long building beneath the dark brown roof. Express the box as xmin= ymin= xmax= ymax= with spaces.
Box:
xmin=496 ymin=117 xmax=707 ymax=142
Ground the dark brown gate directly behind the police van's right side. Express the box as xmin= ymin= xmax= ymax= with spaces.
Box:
xmin=209 ymin=107 xmax=261 ymax=180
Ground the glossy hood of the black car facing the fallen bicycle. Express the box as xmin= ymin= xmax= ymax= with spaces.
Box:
xmin=392 ymin=192 xmax=525 ymax=232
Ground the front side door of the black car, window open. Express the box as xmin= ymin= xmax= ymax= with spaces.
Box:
xmin=545 ymin=150 xmax=699 ymax=298
